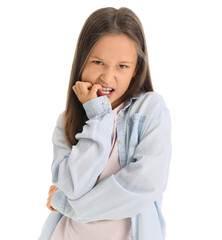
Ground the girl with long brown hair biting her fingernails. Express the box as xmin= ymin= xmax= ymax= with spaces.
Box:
xmin=39 ymin=8 xmax=171 ymax=240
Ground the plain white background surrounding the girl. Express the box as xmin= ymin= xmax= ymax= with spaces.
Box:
xmin=0 ymin=0 xmax=222 ymax=240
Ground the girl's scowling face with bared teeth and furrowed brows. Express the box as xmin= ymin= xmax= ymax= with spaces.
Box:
xmin=82 ymin=34 xmax=137 ymax=108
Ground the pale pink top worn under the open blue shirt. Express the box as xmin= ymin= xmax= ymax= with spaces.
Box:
xmin=50 ymin=103 xmax=131 ymax=240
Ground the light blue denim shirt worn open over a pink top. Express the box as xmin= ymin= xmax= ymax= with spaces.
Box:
xmin=39 ymin=92 xmax=172 ymax=240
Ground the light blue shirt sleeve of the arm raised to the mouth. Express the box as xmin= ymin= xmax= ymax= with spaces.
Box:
xmin=51 ymin=96 xmax=114 ymax=200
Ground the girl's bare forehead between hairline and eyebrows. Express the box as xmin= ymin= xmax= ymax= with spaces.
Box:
xmin=90 ymin=34 xmax=137 ymax=60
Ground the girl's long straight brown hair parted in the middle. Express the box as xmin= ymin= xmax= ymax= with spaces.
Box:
xmin=63 ymin=7 xmax=154 ymax=147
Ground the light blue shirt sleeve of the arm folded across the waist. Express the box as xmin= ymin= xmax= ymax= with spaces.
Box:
xmin=52 ymin=104 xmax=171 ymax=223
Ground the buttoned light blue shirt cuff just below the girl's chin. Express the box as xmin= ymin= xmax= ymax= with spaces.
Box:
xmin=83 ymin=96 xmax=112 ymax=119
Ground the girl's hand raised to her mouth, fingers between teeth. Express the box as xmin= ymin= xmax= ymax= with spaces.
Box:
xmin=72 ymin=81 xmax=102 ymax=104
